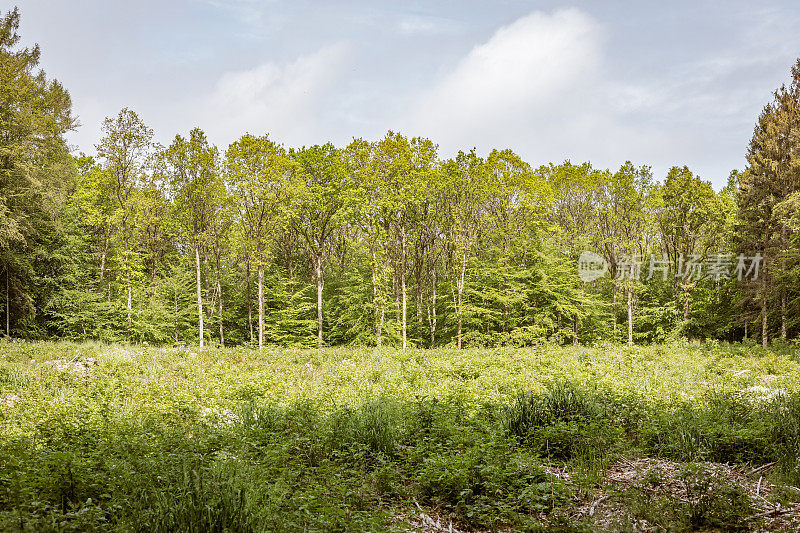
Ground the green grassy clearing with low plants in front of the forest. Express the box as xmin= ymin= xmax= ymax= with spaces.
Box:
xmin=0 ymin=342 xmax=800 ymax=532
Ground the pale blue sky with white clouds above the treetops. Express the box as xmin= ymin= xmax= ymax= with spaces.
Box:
xmin=10 ymin=0 xmax=800 ymax=189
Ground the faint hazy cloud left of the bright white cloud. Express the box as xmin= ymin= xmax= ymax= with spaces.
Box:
xmin=193 ymin=43 xmax=349 ymax=146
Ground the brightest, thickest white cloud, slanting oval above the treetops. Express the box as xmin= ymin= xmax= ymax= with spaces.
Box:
xmin=407 ymin=9 xmax=602 ymax=147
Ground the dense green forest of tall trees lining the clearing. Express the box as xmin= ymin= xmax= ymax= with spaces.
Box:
xmin=0 ymin=10 xmax=800 ymax=348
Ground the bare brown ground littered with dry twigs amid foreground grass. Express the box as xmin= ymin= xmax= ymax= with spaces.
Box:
xmin=404 ymin=458 xmax=800 ymax=533
